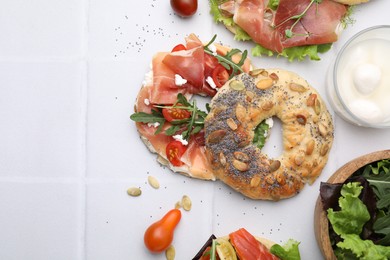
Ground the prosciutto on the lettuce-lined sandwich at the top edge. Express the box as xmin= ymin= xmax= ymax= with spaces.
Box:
xmin=229 ymin=0 xmax=347 ymax=53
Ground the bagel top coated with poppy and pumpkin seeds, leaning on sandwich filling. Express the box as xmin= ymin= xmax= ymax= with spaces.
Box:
xmin=205 ymin=69 xmax=334 ymax=200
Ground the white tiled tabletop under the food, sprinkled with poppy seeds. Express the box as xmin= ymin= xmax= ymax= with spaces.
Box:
xmin=0 ymin=0 xmax=390 ymax=260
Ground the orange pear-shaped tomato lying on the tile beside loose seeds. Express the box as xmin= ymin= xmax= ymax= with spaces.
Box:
xmin=144 ymin=209 xmax=181 ymax=253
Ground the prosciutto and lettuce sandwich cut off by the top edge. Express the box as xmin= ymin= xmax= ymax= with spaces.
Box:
xmin=209 ymin=0 xmax=368 ymax=61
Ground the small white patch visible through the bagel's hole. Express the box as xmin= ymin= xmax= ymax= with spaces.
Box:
xmin=261 ymin=116 xmax=283 ymax=158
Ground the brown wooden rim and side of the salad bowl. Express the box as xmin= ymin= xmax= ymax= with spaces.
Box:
xmin=314 ymin=150 xmax=390 ymax=260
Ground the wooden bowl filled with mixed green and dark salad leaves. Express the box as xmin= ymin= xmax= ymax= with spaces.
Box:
xmin=314 ymin=150 xmax=390 ymax=259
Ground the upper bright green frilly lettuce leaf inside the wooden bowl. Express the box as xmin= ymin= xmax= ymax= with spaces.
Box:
xmin=327 ymin=182 xmax=370 ymax=235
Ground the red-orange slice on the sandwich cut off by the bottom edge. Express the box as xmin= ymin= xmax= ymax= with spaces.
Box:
xmin=229 ymin=228 xmax=279 ymax=260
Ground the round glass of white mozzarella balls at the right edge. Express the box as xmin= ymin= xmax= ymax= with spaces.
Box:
xmin=329 ymin=26 xmax=390 ymax=127
